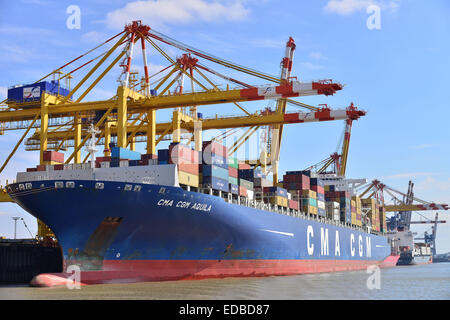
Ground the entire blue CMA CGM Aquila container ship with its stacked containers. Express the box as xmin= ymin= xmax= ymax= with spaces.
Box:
xmin=7 ymin=141 xmax=399 ymax=286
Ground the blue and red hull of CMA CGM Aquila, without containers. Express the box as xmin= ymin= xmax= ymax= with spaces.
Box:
xmin=8 ymin=180 xmax=398 ymax=285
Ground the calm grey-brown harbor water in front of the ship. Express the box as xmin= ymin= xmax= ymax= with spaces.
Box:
xmin=0 ymin=263 xmax=450 ymax=300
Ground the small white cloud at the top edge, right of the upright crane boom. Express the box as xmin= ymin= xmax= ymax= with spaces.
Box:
xmin=324 ymin=0 xmax=400 ymax=16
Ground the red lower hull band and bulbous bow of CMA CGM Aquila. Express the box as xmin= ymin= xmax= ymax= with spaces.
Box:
xmin=30 ymin=256 xmax=399 ymax=287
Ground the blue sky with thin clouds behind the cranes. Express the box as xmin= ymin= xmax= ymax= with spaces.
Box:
xmin=0 ymin=0 xmax=450 ymax=252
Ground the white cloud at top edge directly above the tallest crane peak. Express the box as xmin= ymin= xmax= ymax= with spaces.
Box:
xmin=106 ymin=0 xmax=250 ymax=29
